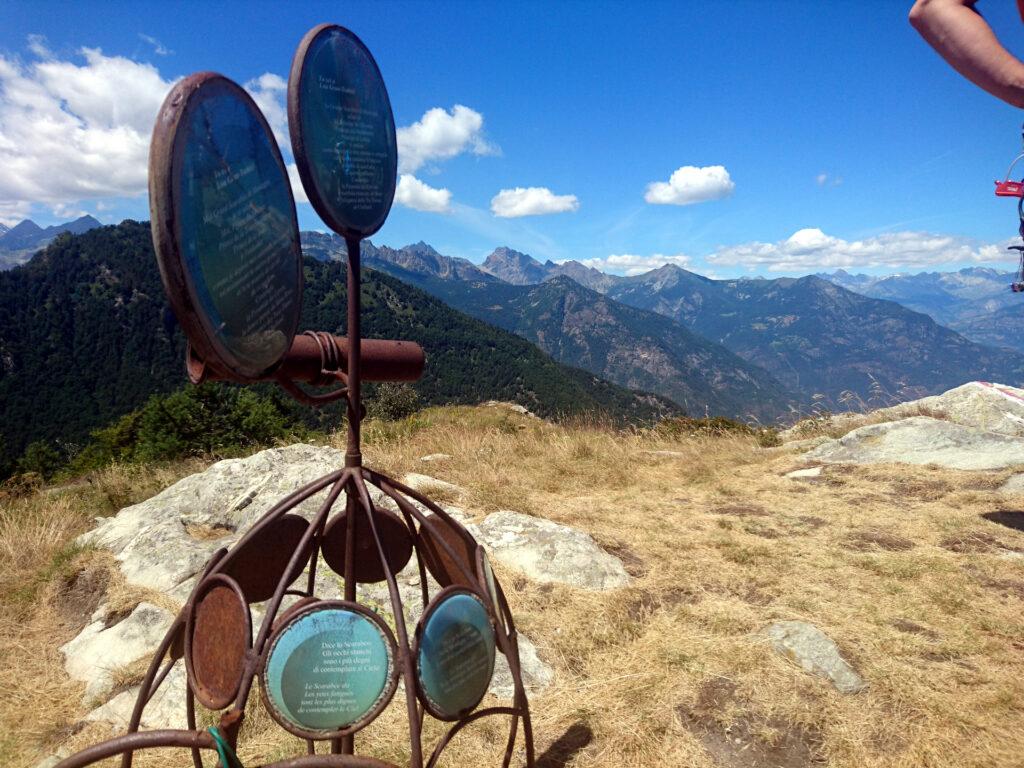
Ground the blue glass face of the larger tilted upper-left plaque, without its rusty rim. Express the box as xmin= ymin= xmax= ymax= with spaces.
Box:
xmin=174 ymin=79 xmax=302 ymax=379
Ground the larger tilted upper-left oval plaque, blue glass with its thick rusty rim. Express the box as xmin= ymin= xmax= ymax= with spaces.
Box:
xmin=150 ymin=73 xmax=302 ymax=381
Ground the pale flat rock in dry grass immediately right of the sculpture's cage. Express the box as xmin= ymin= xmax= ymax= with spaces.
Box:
xmin=478 ymin=510 xmax=630 ymax=590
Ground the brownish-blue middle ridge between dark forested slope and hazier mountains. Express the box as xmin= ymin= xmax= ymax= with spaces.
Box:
xmin=356 ymin=261 xmax=799 ymax=422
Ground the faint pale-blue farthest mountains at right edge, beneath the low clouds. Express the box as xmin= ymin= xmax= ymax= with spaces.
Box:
xmin=818 ymin=267 xmax=1024 ymax=351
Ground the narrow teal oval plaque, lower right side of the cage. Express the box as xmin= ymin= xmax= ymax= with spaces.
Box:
xmin=416 ymin=587 xmax=495 ymax=720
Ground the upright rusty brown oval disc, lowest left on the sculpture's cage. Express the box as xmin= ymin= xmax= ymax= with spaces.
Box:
xmin=184 ymin=573 xmax=253 ymax=710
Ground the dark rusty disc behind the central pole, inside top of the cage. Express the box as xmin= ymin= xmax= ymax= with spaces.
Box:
xmin=321 ymin=509 xmax=413 ymax=584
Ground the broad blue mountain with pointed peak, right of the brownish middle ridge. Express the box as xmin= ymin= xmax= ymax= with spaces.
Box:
xmin=608 ymin=266 xmax=1024 ymax=406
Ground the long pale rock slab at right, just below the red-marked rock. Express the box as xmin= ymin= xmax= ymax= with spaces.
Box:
xmin=804 ymin=416 xmax=1024 ymax=470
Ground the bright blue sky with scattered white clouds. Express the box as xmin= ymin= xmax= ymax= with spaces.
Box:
xmin=0 ymin=0 xmax=1024 ymax=276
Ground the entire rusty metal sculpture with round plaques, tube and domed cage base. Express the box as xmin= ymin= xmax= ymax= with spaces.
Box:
xmin=59 ymin=25 xmax=535 ymax=768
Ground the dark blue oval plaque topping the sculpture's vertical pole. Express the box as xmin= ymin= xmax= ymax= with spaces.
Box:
xmin=288 ymin=25 xmax=398 ymax=239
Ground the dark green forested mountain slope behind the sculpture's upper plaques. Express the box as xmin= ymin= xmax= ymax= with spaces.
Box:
xmin=0 ymin=220 xmax=680 ymax=477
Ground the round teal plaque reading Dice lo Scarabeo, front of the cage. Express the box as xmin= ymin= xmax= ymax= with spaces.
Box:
xmin=261 ymin=600 xmax=398 ymax=738
